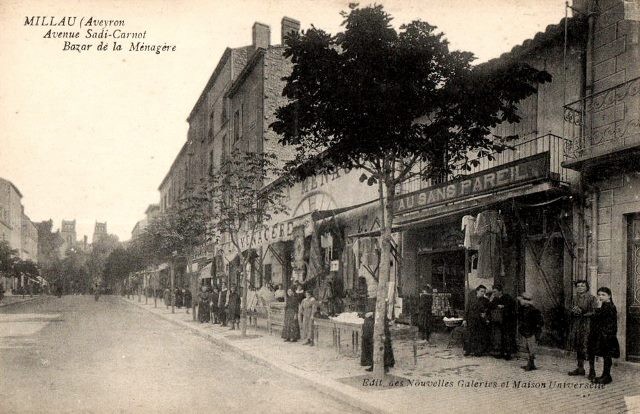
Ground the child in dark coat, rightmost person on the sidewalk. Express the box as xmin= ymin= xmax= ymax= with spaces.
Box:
xmin=588 ymin=287 xmax=620 ymax=384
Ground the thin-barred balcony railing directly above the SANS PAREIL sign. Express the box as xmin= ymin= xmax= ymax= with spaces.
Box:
xmin=396 ymin=134 xmax=571 ymax=195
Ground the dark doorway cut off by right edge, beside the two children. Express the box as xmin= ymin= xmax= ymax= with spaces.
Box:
xmin=625 ymin=213 xmax=640 ymax=362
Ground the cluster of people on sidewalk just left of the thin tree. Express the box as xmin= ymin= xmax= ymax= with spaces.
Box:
xmin=198 ymin=282 xmax=240 ymax=330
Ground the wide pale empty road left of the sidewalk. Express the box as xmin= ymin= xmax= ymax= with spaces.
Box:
xmin=0 ymin=296 xmax=358 ymax=414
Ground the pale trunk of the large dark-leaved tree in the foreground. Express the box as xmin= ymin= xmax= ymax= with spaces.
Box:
xmin=373 ymin=176 xmax=395 ymax=378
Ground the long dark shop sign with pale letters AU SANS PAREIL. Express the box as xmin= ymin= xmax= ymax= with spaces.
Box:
xmin=394 ymin=152 xmax=549 ymax=214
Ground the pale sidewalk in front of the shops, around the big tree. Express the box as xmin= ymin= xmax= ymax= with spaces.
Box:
xmin=123 ymin=297 xmax=640 ymax=413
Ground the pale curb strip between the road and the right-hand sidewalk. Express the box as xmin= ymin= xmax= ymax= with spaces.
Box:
xmin=121 ymin=298 xmax=390 ymax=414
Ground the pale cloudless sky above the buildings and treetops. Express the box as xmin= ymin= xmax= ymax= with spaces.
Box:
xmin=0 ymin=0 xmax=565 ymax=240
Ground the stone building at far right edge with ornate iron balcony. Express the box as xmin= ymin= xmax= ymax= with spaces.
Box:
xmin=554 ymin=0 xmax=640 ymax=362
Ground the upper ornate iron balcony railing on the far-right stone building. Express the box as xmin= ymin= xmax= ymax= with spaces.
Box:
xmin=564 ymin=77 xmax=640 ymax=167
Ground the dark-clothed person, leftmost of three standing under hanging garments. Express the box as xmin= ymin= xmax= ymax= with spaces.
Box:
xmin=464 ymin=285 xmax=489 ymax=356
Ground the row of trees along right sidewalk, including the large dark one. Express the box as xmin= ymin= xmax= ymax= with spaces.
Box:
xmin=117 ymin=4 xmax=551 ymax=377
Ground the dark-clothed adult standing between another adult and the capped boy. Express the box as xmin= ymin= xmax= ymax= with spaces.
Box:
xmin=489 ymin=284 xmax=518 ymax=361
